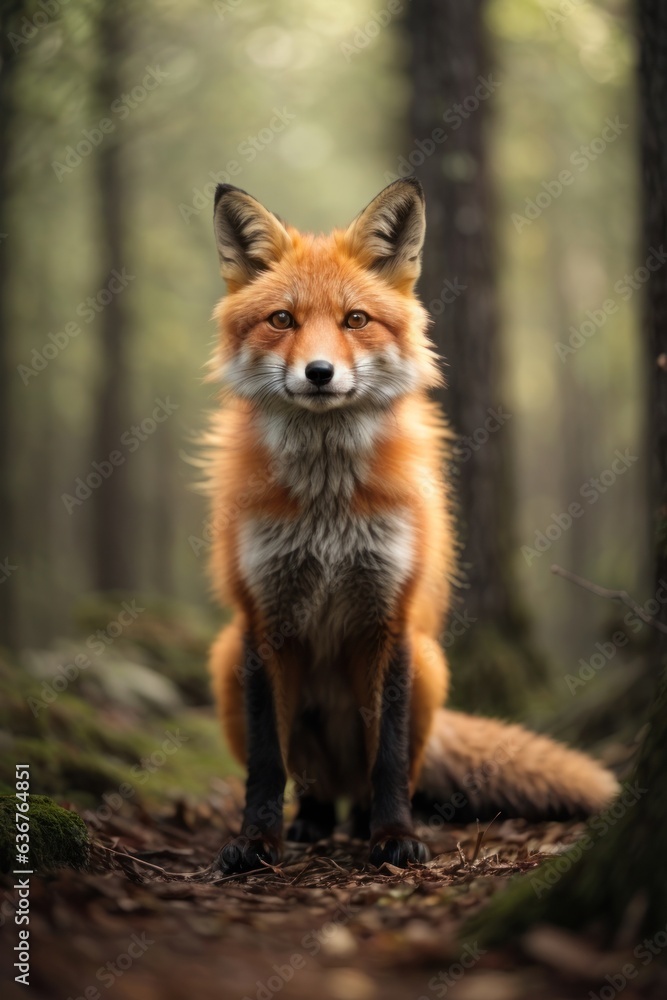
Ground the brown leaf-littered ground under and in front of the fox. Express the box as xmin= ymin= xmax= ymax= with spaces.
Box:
xmin=5 ymin=778 xmax=667 ymax=1000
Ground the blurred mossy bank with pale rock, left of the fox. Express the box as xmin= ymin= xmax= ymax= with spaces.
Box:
xmin=0 ymin=595 xmax=240 ymax=809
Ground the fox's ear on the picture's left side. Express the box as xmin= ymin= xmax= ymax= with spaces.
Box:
xmin=213 ymin=184 xmax=290 ymax=288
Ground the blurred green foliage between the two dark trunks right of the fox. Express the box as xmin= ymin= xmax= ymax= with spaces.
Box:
xmin=487 ymin=0 xmax=650 ymax=684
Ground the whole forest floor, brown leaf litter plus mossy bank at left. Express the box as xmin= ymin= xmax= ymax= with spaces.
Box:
xmin=0 ymin=595 xmax=667 ymax=1000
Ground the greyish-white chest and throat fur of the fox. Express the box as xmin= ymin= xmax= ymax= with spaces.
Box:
xmin=239 ymin=411 xmax=414 ymax=658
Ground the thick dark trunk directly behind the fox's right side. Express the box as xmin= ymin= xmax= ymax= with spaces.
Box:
xmin=408 ymin=0 xmax=546 ymax=715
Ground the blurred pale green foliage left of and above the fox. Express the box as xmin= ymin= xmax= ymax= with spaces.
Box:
xmin=1 ymin=0 xmax=407 ymax=646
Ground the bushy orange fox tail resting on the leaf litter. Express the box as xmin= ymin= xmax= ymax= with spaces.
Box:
xmin=415 ymin=709 xmax=619 ymax=822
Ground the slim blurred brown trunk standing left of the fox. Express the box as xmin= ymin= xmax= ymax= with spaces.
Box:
xmin=91 ymin=0 xmax=135 ymax=591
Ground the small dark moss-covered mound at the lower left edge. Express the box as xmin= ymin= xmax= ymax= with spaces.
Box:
xmin=0 ymin=795 xmax=90 ymax=873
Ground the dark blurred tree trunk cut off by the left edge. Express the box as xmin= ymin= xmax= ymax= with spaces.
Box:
xmin=0 ymin=0 xmax=30 ymax=648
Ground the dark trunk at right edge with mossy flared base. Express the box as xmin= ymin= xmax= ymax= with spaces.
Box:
xmin=471 ymin=0 xmax=667 ymax=942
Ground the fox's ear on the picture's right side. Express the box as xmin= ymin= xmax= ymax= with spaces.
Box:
xmin=345 ymin=177 xmax=426 ymax=287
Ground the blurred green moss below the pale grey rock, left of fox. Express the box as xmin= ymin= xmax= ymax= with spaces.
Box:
xmin=0 ymin=601 xmax=240 ymax=810
